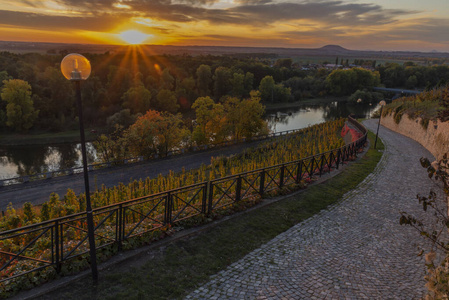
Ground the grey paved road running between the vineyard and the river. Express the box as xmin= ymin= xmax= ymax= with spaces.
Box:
xmin=0 ymin=141 xmax=266 ymax=210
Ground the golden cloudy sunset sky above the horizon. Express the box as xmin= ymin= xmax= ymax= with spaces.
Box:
xmin=0 ymin=0 xmax=449 ymax=52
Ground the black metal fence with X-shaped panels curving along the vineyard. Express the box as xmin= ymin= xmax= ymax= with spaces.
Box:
xmin=0 ymin=118 xmax=367 ymax=283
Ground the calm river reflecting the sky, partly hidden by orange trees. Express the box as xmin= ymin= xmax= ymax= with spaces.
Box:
xmin=0 ymin=101 xmax=377 ymax=179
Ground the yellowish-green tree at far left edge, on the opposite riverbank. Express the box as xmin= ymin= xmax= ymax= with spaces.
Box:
xmin=1 ymin=79 xmax=39 ymax=131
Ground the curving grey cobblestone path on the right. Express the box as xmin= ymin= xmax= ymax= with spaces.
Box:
xmin=187 ymin=120 xmax=433 ymax=299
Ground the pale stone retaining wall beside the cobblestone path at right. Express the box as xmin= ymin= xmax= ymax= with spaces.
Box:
xmin=381 ymin=115 xmax=449 ymax=160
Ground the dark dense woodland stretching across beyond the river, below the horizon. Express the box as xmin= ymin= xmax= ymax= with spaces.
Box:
xmin=0 ymin=50 xmax=449 ymax=131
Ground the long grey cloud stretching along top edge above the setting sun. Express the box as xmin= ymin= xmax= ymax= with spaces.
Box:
xmin=45 ymin=0 xmax=416 ymax=26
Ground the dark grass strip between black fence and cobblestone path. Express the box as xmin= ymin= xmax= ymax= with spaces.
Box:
xmin=36 ymin=133 xmax=383 ymax=300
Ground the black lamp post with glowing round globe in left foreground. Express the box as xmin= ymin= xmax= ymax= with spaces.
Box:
xmin=61 ymin=53 xmax=98 ymax=282
